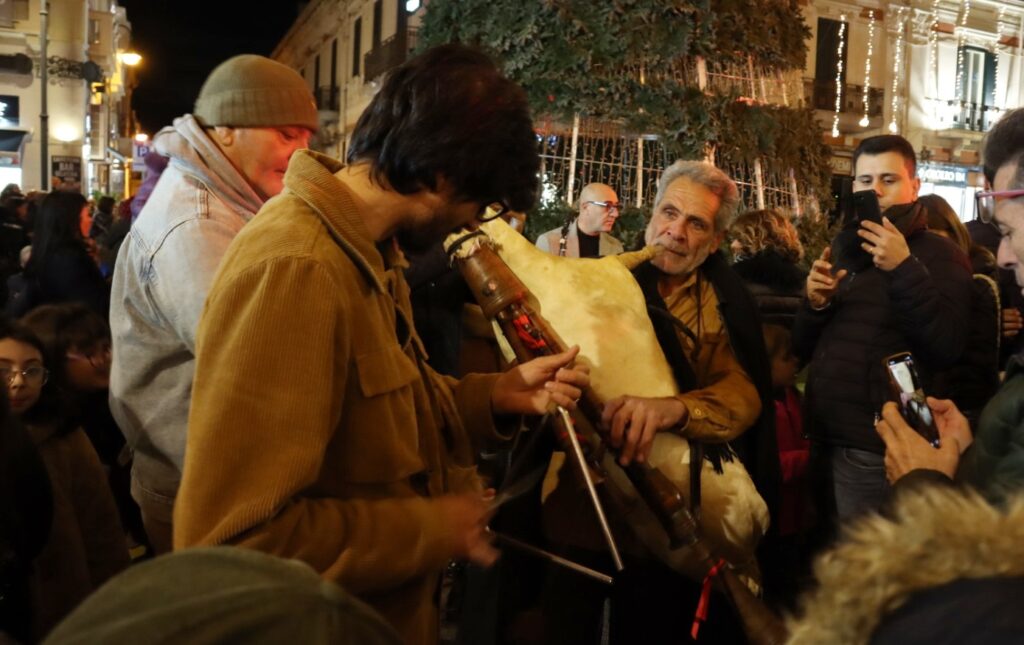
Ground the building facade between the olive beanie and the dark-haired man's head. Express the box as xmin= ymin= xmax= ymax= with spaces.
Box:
xmin=271 ymin=0 xmax=423 ymax=159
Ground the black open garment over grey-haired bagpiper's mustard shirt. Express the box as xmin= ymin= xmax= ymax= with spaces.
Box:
xmin=633 ymin=252 xmax=781 ymax=517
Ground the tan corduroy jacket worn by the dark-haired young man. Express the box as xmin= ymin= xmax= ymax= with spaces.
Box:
xmin=174 ymin=151 xmax=509 ymax=643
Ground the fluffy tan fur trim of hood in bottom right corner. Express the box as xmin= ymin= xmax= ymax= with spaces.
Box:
xmin=787 ymin=485 xmax=1024 ymax=645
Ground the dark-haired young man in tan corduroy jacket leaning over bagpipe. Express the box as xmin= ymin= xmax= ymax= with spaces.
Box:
xmin=174 ymin=45 xmax=589 ymax=644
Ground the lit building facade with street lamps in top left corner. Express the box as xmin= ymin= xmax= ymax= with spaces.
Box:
xmin=0 ymin=0 xmax=135 ymax=197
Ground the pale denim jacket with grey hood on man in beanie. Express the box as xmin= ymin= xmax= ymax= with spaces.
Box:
xmin=111 ymin=115 xmax=263 ymax=506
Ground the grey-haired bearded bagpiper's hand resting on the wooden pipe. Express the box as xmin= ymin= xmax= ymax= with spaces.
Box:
xmin=601 ymin=396 xmax=688 ymax=466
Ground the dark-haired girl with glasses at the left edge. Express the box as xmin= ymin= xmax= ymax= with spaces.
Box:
xmin=0 ymin=323 xmax=128 ymax=640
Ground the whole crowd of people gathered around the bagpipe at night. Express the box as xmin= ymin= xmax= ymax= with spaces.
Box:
xmin=0 ymin=45 xmax=1024 ymax=645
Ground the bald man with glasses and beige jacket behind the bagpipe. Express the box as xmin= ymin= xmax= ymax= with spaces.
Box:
xmin=537 ymin=183 xmax=623 ymax=258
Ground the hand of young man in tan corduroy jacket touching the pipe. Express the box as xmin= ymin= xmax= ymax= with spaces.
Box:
xmin=490 ymin=346 xmax=590 ymax=415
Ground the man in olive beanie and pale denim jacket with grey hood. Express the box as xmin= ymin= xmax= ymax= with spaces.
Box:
xmin=111 ymin=54 xmax=317 ymax=553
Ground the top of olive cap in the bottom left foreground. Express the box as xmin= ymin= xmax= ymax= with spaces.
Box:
xmin=44 ymin=547 xmax=401 ymax=645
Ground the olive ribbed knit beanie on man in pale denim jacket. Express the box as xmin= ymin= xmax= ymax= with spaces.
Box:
xmin=193 ymin=54 xmax=319 ymax=131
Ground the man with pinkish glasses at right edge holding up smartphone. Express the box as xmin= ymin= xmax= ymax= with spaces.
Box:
xmin=877 ymin=109 xmax=1024 ymax=503
